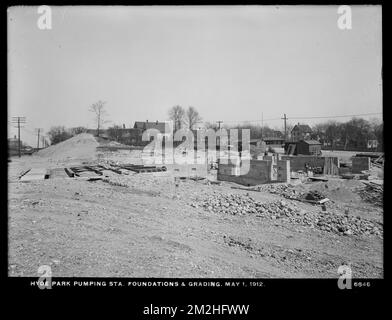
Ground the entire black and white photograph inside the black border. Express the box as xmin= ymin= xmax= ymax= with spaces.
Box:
xmin=7 ymin=5 xmax=385 ymax=288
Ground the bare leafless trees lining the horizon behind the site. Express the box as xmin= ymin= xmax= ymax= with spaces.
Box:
xmin=44 ymin=101 xmax=383 ymax=150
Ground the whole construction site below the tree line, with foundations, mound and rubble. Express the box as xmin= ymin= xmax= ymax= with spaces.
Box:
xmin=8 ymin=133 xmax=384 ymax=278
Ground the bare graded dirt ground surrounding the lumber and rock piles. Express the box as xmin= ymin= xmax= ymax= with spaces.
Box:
xmin=8 ymin=138 xmax=383 ymax=278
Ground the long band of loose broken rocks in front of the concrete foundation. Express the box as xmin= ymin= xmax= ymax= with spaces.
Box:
xmin=190 ymin=193 xmax=383 ymax=237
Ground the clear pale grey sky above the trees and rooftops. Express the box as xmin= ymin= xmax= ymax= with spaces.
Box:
xmin=8 ymin=6 xmax=382 ymax=144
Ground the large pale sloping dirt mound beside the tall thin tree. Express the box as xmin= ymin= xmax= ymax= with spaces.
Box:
xmin=37 ymin=133 xmax=99 ymax=160
